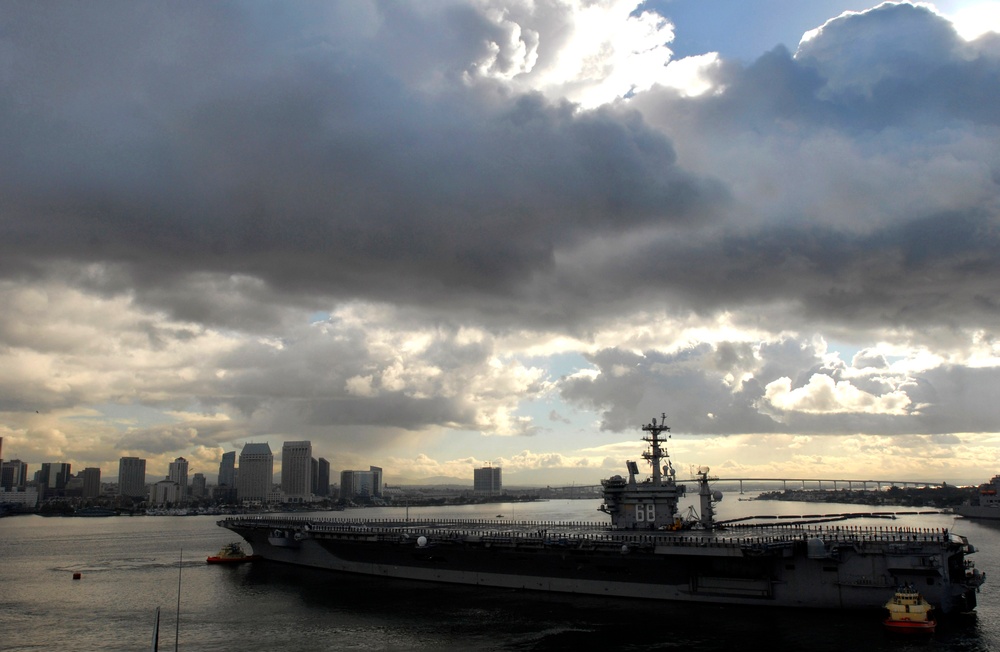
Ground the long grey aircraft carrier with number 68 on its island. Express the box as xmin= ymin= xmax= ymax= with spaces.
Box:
xmin=219 ymin=416 xmax=985 ymax=614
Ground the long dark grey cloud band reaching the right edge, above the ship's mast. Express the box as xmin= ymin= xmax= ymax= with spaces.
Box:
xmin=584 ymin=212 xmax=1000 ymax=327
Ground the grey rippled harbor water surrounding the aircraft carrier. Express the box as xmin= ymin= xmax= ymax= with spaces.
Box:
xmin=0 ymin=501 xmax=1000 ymax=652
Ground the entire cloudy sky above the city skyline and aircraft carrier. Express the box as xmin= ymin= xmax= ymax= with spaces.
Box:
xmin=0 ymin=0 xmax=1000 ymax=486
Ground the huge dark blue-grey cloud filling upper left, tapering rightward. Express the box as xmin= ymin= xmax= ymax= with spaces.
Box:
xmin=0 ymin=4 xmax=722 ymax=320
